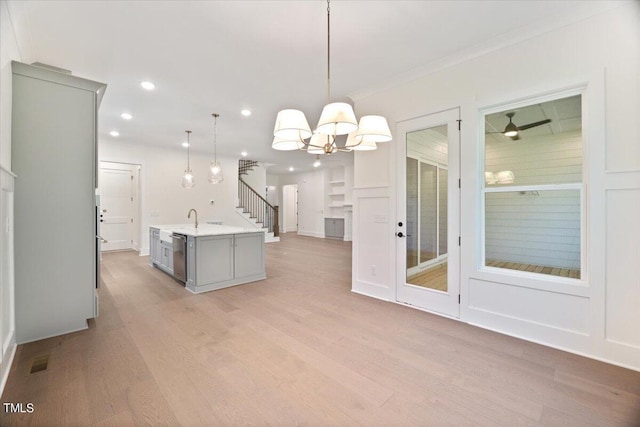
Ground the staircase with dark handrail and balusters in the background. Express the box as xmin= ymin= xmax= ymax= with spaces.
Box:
xmin=236 ymin=159 xmax=280 ymax=243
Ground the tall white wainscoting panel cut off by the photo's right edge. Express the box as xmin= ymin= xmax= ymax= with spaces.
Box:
xmin=605 ymin=189 xmax=640 ymax=348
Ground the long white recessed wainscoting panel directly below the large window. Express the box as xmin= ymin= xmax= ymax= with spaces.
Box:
xmin=469 ymin=279 xmax=589 ymax=335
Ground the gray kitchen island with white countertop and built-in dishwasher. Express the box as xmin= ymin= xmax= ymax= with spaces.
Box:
xmin=149 ymin=224 xmax=267 ymax=294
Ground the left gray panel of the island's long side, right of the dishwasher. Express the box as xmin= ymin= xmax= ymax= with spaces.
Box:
xmin=195 ymin=235 xmax=234 ymax=286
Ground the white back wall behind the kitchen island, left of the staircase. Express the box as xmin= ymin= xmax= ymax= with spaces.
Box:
xmin=98 ymin=141 xmax=248 ymax=255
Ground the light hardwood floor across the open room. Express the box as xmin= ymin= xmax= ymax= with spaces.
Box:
xmin=0 ymin=233 xmax=640 ymax=427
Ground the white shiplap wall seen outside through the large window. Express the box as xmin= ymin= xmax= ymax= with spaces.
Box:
xmin=485 ymin=130 xmax=582 ymax=270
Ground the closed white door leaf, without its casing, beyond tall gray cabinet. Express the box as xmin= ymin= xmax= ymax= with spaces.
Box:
xmin=99 ymin=168 xmax=133 ymax=251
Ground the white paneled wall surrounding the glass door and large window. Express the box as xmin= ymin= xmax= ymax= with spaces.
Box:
xmin=353 ymin=2 xmax=640 ymax=370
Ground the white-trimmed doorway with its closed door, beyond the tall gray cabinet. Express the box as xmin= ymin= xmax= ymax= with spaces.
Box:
xmin=98 ymin=162 xmax=140 ymax=251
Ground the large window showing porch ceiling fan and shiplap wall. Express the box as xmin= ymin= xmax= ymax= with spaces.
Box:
xmin=483 ymin=95 xmax=584 ymax=279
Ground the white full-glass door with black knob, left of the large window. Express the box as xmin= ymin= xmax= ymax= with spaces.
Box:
xmin=396 ymin=108 xmax=460 ymax=317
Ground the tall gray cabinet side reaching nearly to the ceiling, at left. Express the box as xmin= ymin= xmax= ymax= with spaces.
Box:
xmin=11 ymin=62 xmax=106 ymax=344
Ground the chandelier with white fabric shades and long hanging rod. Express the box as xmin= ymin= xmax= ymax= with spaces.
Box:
xmin=271 ymin=0 xmax=391 ymax=155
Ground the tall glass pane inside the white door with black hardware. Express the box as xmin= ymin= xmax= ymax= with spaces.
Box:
xmin=406 ymin=125 xmax=449 ymax=292
